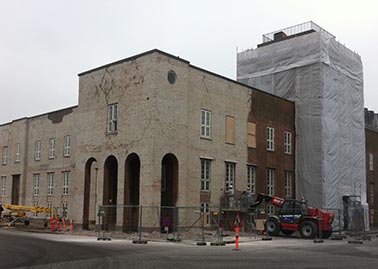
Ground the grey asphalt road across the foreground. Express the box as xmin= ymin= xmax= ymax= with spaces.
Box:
xmin=0 ymin=229 xmax=378 ymax=269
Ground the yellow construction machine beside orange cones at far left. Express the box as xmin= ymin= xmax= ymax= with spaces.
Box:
xmin=1 ymin=204 xmax=54 ymax=226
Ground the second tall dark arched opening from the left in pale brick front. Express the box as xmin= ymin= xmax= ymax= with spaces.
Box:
xmin=102 ymin=156 xmax=118 ymax=228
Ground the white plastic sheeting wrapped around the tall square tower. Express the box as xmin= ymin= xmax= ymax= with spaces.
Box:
xmin=237 ymin=32 xmax=366 ymax=225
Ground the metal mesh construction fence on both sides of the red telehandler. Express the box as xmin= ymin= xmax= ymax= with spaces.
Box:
xmin=96 ymin=205 xmax=365 ymax=242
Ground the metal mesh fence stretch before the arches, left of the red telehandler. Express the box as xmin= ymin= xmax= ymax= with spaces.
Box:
xmin=96 ymin=205 xmax=257 ymax=242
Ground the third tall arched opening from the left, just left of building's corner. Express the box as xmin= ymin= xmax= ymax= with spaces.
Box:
xmin=123 ymin=153 xmax=140 ymax=232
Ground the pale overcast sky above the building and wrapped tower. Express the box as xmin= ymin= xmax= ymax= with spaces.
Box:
xmin=0 ymin=0 xmax=378 ymax=124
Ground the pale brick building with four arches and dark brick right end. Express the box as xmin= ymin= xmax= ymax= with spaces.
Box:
xmin=0 ymin=50 xmax=295 ymax=228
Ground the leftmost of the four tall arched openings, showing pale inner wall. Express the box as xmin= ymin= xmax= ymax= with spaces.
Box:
xmin=82 ymin=158 xmax=98 ymax=230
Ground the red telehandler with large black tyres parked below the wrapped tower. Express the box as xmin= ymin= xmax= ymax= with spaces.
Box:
xmin=251 ymin=193 xmax=335 ymax=238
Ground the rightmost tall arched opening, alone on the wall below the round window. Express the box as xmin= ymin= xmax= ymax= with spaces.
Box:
xmin=160 ymin=153 xmax=178 ymax=230
